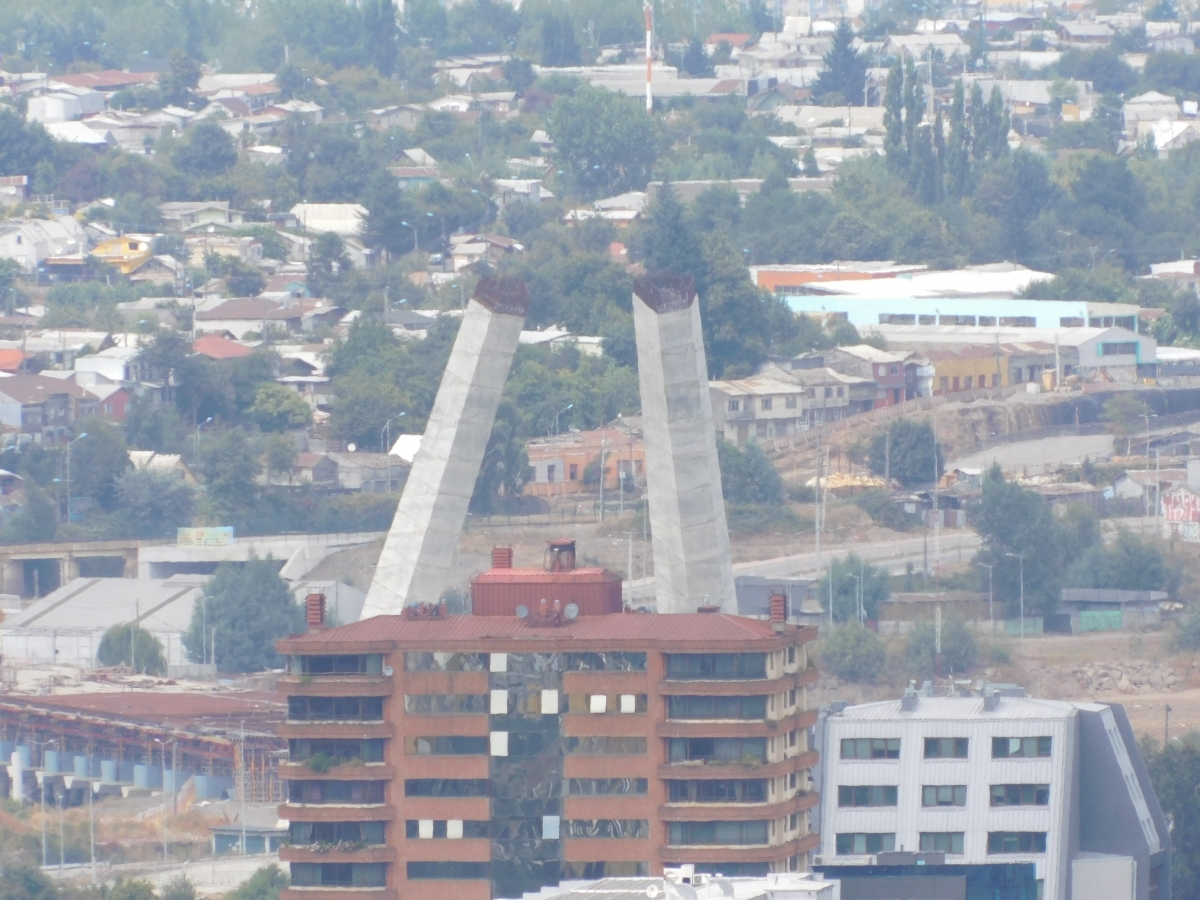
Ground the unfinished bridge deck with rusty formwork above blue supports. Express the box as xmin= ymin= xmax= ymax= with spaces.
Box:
xmin=0 ymin=679 xmax=287 ymax=805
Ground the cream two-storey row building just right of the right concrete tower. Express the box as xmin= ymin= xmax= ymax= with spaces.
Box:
xmin=709 ymin=368 xmax=876 ymax=446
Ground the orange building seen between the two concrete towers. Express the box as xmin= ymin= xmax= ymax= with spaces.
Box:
xmin=524 ymin=416 xmax=646 ymax=497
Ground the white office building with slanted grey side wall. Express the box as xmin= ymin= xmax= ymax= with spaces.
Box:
xmin=812 ymin=690 xmax=1170 ymax=900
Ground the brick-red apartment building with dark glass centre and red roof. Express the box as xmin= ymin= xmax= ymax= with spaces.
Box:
xmin=276 ymin=541 xmax=818 ymax=900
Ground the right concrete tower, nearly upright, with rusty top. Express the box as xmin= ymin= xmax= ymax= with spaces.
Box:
xmin=634 ymin=272 xmax=738 ymax=613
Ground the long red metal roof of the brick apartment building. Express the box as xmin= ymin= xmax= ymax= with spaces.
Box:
xmin=290 ymin=612 xmax=775 ymax=647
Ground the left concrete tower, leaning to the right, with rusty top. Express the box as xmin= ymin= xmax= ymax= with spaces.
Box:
xmin=362 ymin=277 xmax=529 ymax=618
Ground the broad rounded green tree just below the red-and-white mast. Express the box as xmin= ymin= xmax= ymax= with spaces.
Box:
xmin=547 ymin=88 xmax=665 ymax=198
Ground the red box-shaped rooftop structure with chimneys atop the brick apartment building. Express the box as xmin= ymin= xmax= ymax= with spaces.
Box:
xmin=470 ymin=540 xmax=623 ymax=616
